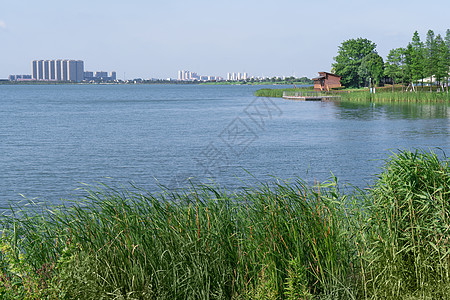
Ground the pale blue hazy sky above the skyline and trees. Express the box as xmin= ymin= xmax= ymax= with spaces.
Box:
xmin=0 ymin=0 xmax=450 ymax=79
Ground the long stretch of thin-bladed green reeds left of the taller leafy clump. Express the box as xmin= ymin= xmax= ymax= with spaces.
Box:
xmin=2 ymin=181 xmax=356 ymax=299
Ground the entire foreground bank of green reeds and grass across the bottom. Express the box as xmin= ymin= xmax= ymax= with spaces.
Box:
xmin=0 ymin=151 xmax=450 ymax=299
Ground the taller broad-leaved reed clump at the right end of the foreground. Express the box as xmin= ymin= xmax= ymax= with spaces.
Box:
xmin=368 ymin=151 xmax=450 ymax=299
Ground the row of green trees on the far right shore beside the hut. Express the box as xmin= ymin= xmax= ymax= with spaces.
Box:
xmin=332 ymin=29 xmax=450 ymax=91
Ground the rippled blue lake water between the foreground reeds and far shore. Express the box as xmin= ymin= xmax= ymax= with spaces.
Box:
xmin=0 ymin=85 xmax=450 ymax=206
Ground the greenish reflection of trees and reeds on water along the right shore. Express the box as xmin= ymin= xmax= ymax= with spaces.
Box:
xmin=333 ymin=101 xmax=450 ymax=120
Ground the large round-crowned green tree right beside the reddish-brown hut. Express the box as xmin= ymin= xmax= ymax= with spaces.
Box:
xmin=332 ymin=38 xmax=376 ymax=87
